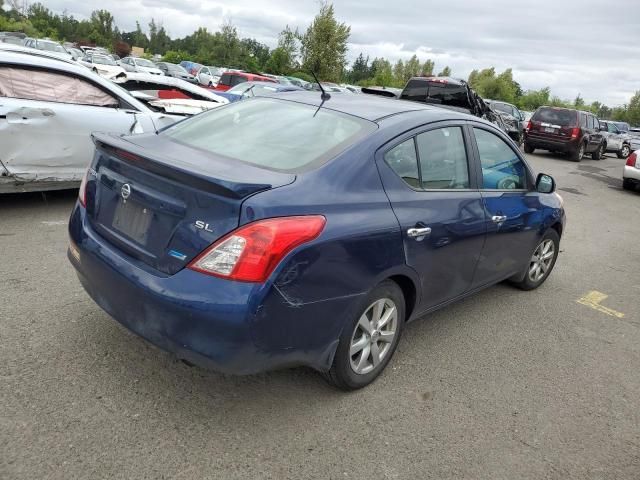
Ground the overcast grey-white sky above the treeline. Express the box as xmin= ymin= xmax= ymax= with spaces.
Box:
xmin=41 ymin=0 xmax=640 ymax=106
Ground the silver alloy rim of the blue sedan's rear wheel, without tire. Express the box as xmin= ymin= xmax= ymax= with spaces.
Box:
xmin=349 ymin=298 xmax=398 ymax=375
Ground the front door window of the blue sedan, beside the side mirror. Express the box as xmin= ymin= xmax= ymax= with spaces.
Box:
xmin=473 ymin=128 xmax=527 ymax=190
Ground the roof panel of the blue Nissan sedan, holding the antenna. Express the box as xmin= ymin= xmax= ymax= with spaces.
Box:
xmin=263 ymin=90 xmax=468 ymax=122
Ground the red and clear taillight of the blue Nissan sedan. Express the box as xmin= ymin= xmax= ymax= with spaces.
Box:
xmin=188 ymin=215 xmax=326 ymax=282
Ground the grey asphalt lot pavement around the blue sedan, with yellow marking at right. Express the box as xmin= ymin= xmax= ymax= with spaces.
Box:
xmin=0 ymin=153 xmax=640 ymax=480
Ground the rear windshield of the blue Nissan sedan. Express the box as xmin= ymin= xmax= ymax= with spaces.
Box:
xmin=164 ymin=98 xmax=376 ymax=172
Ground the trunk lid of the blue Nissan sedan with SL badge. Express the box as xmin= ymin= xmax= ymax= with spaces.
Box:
xmin=86 ymin=134 xmax=295 ymax=274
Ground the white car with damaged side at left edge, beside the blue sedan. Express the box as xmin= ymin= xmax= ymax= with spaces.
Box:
xmin=0 ymin=49 xmax=179 ymax=193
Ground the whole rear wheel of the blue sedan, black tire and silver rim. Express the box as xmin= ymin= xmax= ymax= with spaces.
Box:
xmin=325 ymin=280 xmax=405 ymax=390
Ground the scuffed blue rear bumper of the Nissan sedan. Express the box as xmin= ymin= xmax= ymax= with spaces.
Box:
xmin=68 ymin=206 xmax=353 ymax=374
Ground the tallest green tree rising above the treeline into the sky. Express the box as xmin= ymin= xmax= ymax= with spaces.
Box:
xmin=300 ymin=3 xmax=351 ymax=82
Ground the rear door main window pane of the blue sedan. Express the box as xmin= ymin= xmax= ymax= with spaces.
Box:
xmin=416 ymin=127 xmax=469 ymax=190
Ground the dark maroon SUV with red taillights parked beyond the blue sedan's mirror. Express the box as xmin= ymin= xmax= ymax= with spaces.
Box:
xmin=524 ymin=107 xmax=605 ymax=162
